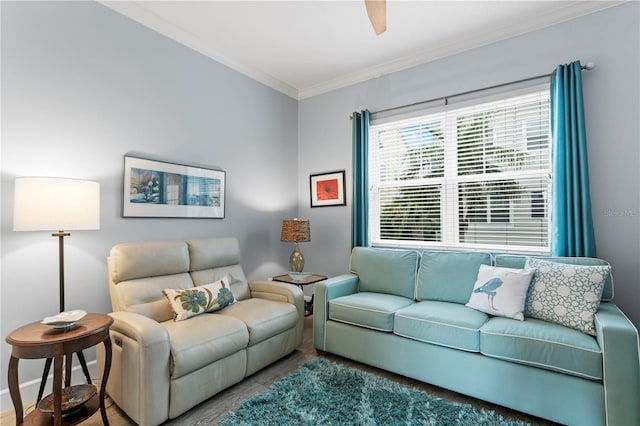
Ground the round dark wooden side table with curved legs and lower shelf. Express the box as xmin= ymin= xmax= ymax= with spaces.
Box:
xmin=5 ymin=314 xmax=113 ymax=426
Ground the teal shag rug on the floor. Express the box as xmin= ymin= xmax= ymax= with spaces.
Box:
xmin=220 ymin=358 xmax=527 ymax=426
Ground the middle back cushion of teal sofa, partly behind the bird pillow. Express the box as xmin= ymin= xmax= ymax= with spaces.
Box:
xmin=416 ymin=251 xmax=492 ymax=305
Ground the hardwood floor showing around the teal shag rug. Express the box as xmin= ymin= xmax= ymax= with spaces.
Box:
xmin=0 ymin=317 xmax=554 ymax=426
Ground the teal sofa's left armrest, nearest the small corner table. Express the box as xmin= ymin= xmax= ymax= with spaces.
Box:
xmin=313 ymin=274 xmax=358 ymax=351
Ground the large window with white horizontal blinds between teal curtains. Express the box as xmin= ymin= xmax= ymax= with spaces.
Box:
xmin=369 ymin=88 xmax=551 ymax=252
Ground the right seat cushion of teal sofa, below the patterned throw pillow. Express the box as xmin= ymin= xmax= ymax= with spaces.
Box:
xmin=480 ymin=317 xmax=602 ymax=380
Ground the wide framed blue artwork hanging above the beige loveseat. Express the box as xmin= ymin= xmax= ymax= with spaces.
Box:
xmin=122 ymin=156 xmax=225 ymax=219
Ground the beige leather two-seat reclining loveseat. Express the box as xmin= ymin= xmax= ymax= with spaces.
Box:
xmin=97 ymin=238 xmax=304 ymax=425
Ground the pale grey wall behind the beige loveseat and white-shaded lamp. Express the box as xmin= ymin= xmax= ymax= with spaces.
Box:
xmin=0 ymin=1 xmax=298 ymax=410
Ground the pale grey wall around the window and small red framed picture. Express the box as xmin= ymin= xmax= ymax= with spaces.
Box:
xmin=298 ymin=2 xmax=640 ymax=326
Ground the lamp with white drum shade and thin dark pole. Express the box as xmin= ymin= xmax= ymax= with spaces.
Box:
xmin=13 ymin=177 xmax=100 ymax=312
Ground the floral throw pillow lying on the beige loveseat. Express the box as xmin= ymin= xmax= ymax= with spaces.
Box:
xmin=163 ymin=277 xmax=236 ymax=321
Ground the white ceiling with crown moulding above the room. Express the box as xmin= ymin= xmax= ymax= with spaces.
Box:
xmin=101 ymin=0 xmax=622 ymax=99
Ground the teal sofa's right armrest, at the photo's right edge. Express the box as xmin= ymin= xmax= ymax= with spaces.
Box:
xmin=595 ymin=302 xmax=640 ymax=425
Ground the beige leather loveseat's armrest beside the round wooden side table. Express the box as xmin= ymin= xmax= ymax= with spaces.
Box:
xmin=97 ymin=312 xmax=171 ymax=425
